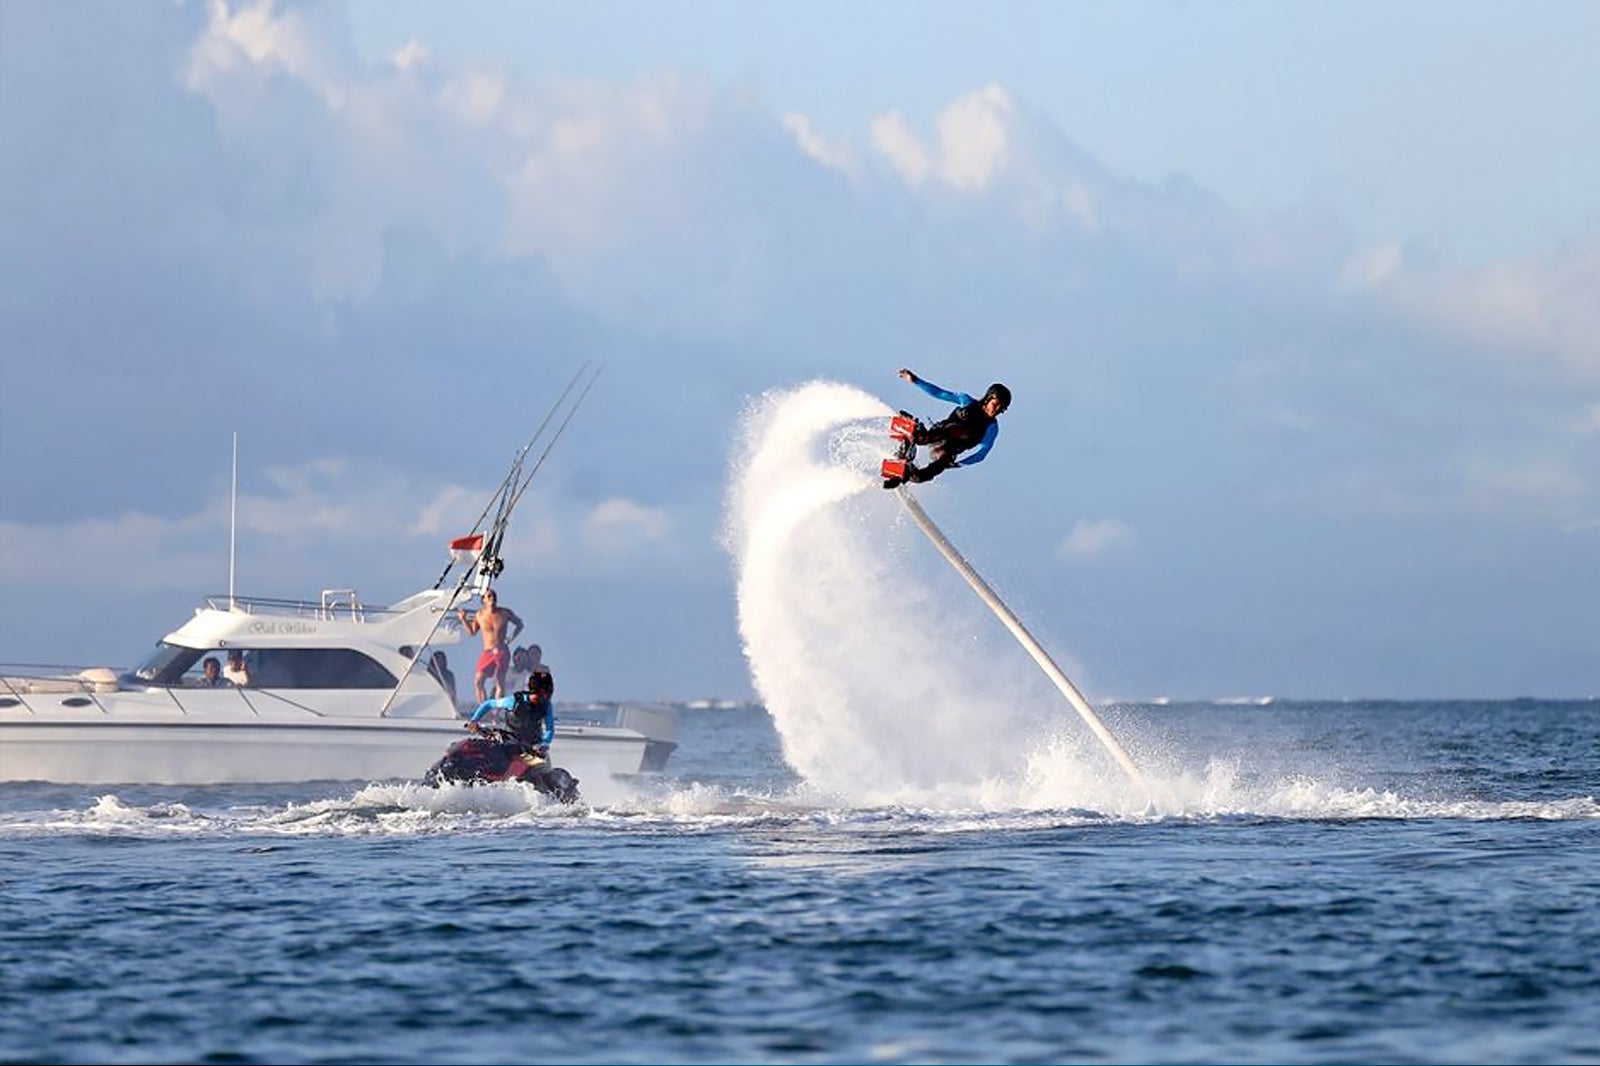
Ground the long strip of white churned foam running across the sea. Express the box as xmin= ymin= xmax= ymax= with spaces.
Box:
xmin=0 ymin=771 xmax=1600 ymax=845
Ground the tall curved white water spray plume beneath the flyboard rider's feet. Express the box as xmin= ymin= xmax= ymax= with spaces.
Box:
xmin=725 ymin=383 xmax=1139 ymax=804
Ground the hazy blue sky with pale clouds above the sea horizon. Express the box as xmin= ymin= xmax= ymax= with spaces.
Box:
xmin=0 ymin=0 xmax=1600 ymax=698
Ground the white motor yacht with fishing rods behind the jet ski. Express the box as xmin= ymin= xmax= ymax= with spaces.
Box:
xmin=0 ymin=589 xmax=677 ymax=784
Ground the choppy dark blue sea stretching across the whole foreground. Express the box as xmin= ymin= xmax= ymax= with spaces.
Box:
xmin=0 ymin=699 xmax=1600 ymax=1063
